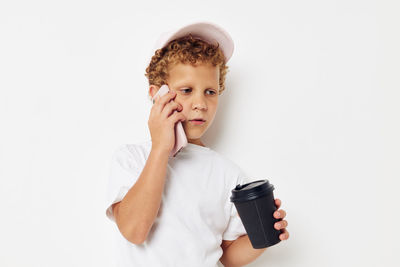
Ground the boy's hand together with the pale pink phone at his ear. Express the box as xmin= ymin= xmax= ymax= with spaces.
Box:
xmin=148 ymin=85 xmax=187 ymax=157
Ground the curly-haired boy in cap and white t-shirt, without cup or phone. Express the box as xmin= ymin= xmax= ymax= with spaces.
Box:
xmin=106 ymin=22 xmax=289 ymax=267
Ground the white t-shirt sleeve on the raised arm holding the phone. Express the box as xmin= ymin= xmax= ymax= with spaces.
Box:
xmin=105 ymin=145 xmax=143 ymax=222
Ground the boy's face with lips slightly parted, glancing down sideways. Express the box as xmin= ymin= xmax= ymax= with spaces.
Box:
xmin=162 ymin=63 xmax=219 ymax=145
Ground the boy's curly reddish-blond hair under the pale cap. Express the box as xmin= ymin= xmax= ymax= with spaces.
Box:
xmin=145 ymin=33 xmax=228 ymax=98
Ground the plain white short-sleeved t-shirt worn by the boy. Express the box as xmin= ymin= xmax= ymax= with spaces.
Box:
xmin=106 ymin=140 xmax=246 ymax=267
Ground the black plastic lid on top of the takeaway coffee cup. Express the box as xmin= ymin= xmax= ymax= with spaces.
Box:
xmin=230 ymin=179 xmax=274 ymax=202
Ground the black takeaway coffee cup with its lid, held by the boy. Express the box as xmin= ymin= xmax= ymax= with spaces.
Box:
xmin=230 ymin=180 xmax=282 ymax=248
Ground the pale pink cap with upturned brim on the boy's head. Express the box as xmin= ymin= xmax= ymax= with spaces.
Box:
xmin=149 ymin=21 xmax=234 ymax=66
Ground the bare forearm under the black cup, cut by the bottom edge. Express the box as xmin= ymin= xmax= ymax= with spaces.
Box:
xmin=220 ymin=235 xmax=267 ymax=267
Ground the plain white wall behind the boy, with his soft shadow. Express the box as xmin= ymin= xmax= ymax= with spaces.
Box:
xmin=0 ymin=0 xmax=400 ymax=267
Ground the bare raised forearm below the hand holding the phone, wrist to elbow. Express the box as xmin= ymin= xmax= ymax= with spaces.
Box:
xmin=113 ymin=149 xmax=169 ymax=244
